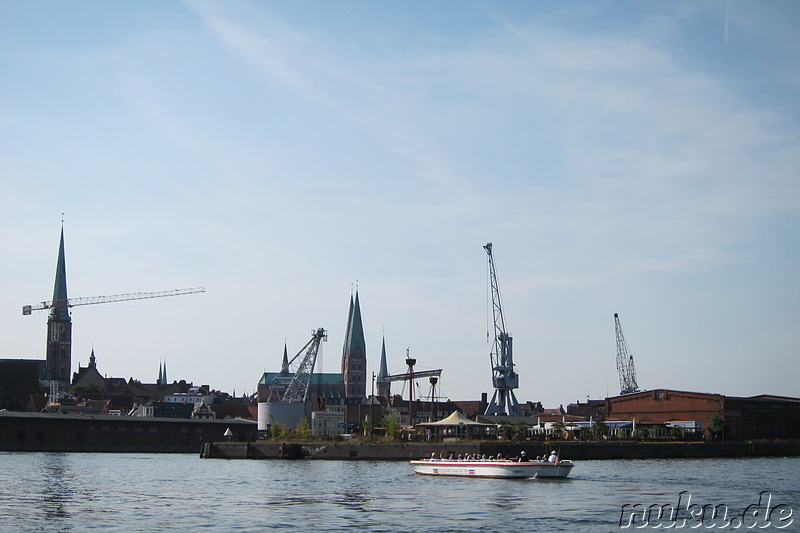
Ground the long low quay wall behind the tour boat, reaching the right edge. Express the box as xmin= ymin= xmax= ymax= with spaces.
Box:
xmin=201 ymin=440 xmax=800 ymax=461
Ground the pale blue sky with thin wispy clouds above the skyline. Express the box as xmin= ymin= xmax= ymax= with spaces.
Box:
xmin=0 ymin=0 xmax=800 ymax=407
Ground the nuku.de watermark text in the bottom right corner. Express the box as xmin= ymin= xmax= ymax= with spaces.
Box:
xmin=619 ymin=490 xmax=794 ymax=529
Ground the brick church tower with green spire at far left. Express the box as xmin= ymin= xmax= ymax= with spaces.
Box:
xmin=46 ymin=224 xmax=72 ymax=384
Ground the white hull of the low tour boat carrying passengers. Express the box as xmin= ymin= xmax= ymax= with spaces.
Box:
xmin=410 ymin=459 xmax=574 ymax=479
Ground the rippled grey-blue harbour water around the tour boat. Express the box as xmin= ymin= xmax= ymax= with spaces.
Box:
xmin=0 ymin=453 xmax=800 ymax=533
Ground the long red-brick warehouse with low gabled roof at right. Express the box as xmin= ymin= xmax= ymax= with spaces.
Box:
xmin=606 ymin=389 xmax=800 ymax=440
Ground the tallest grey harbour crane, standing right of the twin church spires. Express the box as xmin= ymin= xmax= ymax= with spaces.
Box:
xmin=483 ymin=243 xmax=523 ymax=416
